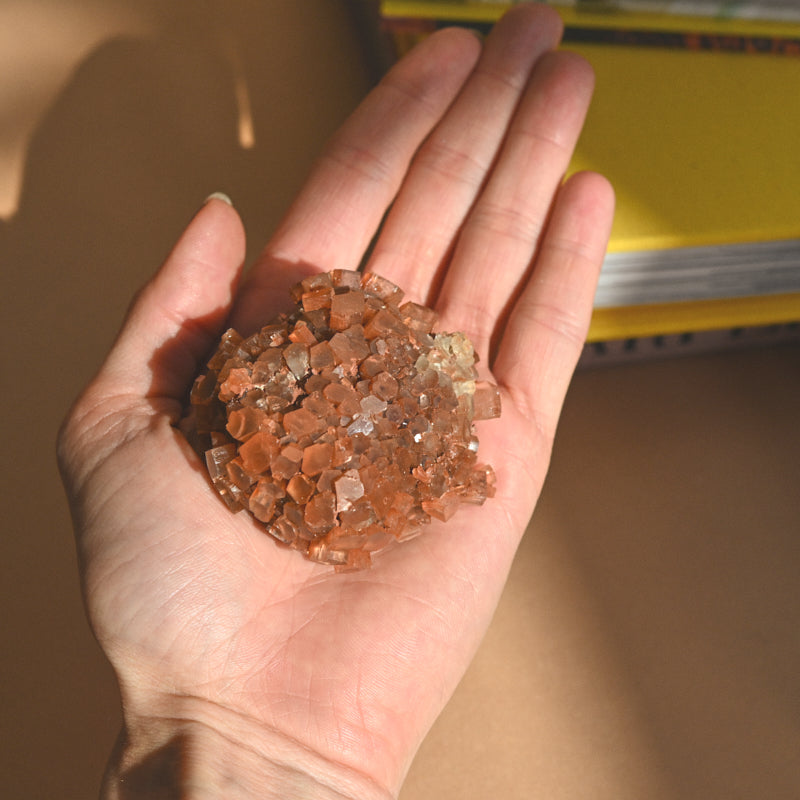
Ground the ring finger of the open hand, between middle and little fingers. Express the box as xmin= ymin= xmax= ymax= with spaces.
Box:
xmin=437 ymin=53 xmax=594 ymax=356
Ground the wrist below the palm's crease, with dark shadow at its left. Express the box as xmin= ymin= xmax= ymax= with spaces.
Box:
xmin=102 ymin=698 xmax=393 ymax=800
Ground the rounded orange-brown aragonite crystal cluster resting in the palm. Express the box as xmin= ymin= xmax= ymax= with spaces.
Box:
xmin=190 ymin=270 xmax=500 ymax=570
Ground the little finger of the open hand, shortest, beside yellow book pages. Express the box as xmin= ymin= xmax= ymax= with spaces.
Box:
xmin=493 ymin=173 xmax=614 ymax=442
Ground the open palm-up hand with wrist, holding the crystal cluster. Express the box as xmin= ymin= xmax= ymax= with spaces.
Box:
xmin=59 ymin=6 xmax=613 ymax=798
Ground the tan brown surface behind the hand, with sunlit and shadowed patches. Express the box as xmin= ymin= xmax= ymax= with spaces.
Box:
xmin=0 ymin=0 xmax=800 ymax=800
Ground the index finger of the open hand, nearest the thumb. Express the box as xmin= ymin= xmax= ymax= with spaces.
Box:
xmin=234 ymin=29 xmax=480 ymax=328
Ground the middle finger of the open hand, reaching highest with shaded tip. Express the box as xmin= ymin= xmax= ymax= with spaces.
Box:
xmin=368 ymin=5 xmax=562 ymax=303
